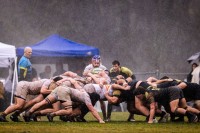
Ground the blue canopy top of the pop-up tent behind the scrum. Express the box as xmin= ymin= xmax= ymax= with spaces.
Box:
xmin=17 ymin=34 xmax=99 ymax=57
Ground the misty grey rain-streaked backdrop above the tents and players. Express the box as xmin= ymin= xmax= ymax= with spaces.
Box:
xmin=0 ymin=0 xmax=200 ymax=79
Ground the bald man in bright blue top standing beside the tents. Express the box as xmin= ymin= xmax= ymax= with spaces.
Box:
xmin=18 ymin=47 xmax=32 ymax=81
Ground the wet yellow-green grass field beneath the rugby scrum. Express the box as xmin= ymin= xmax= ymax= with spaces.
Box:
xmin=0 ymin=112 xmax=200 ymax=133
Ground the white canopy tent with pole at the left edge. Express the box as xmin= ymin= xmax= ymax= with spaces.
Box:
xmin=0 ymin=42 xmax=18 ymax=104
